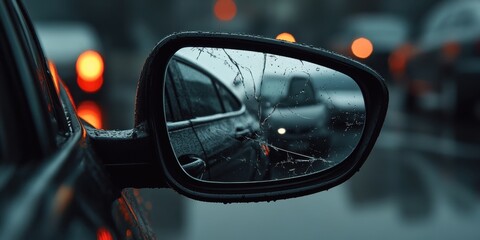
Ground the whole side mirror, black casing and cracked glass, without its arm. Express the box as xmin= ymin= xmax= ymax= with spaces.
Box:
xmin=136 ymin=33 xmax=388 ymax=202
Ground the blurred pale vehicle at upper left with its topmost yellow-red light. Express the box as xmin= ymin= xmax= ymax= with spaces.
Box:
xmin=35 ymin=22 xmax=104 ymax=97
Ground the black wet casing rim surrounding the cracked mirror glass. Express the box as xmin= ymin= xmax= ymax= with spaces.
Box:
xmin=135 ymin=32 xmax=388 ymax=202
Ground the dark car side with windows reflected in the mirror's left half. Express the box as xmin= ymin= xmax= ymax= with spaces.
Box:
xmin=166 ymin=56 xmax=261 ymax=181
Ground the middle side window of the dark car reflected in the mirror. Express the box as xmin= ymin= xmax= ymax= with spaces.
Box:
xmin=178 ymin=62 xmax=223 ymax=117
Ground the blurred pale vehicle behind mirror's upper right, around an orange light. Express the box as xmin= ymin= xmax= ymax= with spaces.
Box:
xmin=332 ymin=14 xmax=408 ymax=77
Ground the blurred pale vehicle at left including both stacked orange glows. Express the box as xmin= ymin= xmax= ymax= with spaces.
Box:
xmin=35 ymin=21 xmax=105 ymax=128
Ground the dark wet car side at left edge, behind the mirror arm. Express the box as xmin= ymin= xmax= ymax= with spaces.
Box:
xmin=0 ymin=1 xmax=122 ymax=239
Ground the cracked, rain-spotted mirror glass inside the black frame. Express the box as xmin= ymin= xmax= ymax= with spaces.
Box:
xmin=164 ymin=47 xmax=365 ymax=182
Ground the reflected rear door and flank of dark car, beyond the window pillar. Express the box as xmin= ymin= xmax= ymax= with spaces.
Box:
xmin=172 ymin=58 xmax=266 ymax=181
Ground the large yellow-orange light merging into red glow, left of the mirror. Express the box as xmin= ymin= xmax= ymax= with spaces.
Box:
xmin=76 ymin=50 xmax=105 ymax=93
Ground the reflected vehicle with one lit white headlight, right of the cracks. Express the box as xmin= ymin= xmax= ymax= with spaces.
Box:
xmin=261 ymin=75 xmax=331 ymax=160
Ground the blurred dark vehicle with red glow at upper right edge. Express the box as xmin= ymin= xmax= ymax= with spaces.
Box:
xmin=406 ymin=1 xmax=480 ymax=117
